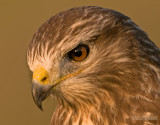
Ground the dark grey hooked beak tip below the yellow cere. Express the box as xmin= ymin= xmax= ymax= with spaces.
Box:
xmin=32 ymin=81 xmax=53 ymax=110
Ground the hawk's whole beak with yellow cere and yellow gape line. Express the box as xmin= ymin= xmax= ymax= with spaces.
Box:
xmin=32 ymin=66 xmax=82 ymax=110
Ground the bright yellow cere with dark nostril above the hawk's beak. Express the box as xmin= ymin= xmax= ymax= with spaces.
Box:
xmin=33 ymin=66 xmax=51 ymax=85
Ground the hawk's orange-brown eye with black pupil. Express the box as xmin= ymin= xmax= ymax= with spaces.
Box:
xmin=69 ymin=45 xmax=89 ymax=61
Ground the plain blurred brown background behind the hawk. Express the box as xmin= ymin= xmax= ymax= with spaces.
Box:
xmin=0 ymin=0 xmax=160 ymax=125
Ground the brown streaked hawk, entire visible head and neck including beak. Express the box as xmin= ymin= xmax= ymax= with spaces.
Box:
xmin=27 ymin=6 xmax=160 ymax=125
